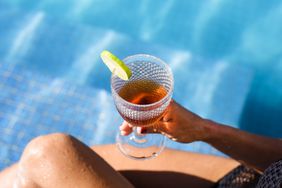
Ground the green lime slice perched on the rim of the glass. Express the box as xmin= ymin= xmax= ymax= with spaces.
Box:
xmin=100 ymin=50 xmax=132 ymax=80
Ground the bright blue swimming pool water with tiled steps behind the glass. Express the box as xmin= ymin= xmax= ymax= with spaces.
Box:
xmin=0 ymin=0 xmax=282 ymax=169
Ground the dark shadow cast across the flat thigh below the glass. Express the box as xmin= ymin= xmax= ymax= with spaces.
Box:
xmin=119 ymin=170 xmax=214 ymax=188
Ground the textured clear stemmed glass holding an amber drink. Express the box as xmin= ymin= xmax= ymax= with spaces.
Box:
xmin=111 ymin=54 xmax=174 ymax=159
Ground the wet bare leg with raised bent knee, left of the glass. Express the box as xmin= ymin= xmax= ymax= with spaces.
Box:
xmin=0 ymin=134 xmax=132 ymax=188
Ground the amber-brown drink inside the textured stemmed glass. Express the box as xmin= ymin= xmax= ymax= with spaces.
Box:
xmin=119 ymin=80 xmax=167 ymax=126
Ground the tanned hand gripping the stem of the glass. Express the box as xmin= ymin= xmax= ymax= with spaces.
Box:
xmin=120 ymin=101 xmax=208 ymax=143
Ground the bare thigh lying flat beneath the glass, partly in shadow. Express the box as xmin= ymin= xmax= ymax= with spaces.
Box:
xmin=92 ymin=145 xmax=239 ymax=187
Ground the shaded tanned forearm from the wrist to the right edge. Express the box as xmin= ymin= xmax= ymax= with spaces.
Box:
xmin=205 ymin=121 xmax=282 ymax=171
